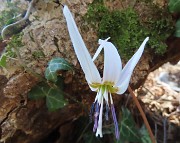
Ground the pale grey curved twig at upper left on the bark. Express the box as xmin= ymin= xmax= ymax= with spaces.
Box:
xmin=1 ymin=0 xmax=34 ymax=40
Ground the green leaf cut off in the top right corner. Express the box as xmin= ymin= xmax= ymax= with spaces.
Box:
xmin=168 ymin=0 xmax=180 ymax=13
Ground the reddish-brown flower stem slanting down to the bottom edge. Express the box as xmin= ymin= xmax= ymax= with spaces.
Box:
xmin=128 ymin=86 xmax=156 ymax=143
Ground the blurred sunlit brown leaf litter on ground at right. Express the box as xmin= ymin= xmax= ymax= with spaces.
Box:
xmin=136 ymin=62 xmax=180 ymax=143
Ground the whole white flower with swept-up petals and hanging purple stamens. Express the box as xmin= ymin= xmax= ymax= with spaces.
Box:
xmin=63 ymin=6 xmax=149 ymax=139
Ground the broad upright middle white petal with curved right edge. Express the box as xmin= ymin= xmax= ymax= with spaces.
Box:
xmin=102 ymin=42 xmax=122 ymax=84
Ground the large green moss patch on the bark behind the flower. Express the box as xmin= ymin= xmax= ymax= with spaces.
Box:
xmin=85 ymin=2 xmax=173 ymax=60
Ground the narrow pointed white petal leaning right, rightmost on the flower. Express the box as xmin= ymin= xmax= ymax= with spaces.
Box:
xmin=117 ymin=37 xmax=149 ymax=94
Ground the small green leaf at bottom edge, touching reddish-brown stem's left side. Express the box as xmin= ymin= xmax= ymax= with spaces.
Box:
xmin=139 ymin=125 xmax=151 ymax=143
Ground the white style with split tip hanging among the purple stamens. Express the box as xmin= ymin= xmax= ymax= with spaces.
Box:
xmin=96 ymin=96 xmax=103 ymax=137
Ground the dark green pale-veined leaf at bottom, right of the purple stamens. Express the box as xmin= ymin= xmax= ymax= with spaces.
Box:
xmin=120 ymin=108 xmax=141 ymax=142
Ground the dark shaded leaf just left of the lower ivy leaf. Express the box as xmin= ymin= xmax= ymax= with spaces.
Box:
xmin=28 ymin=83 xmax=47 ymax=100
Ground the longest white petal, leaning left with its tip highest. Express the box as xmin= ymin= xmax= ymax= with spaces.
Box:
xmin=63 ymin=6 xmax=101 ymax=83
